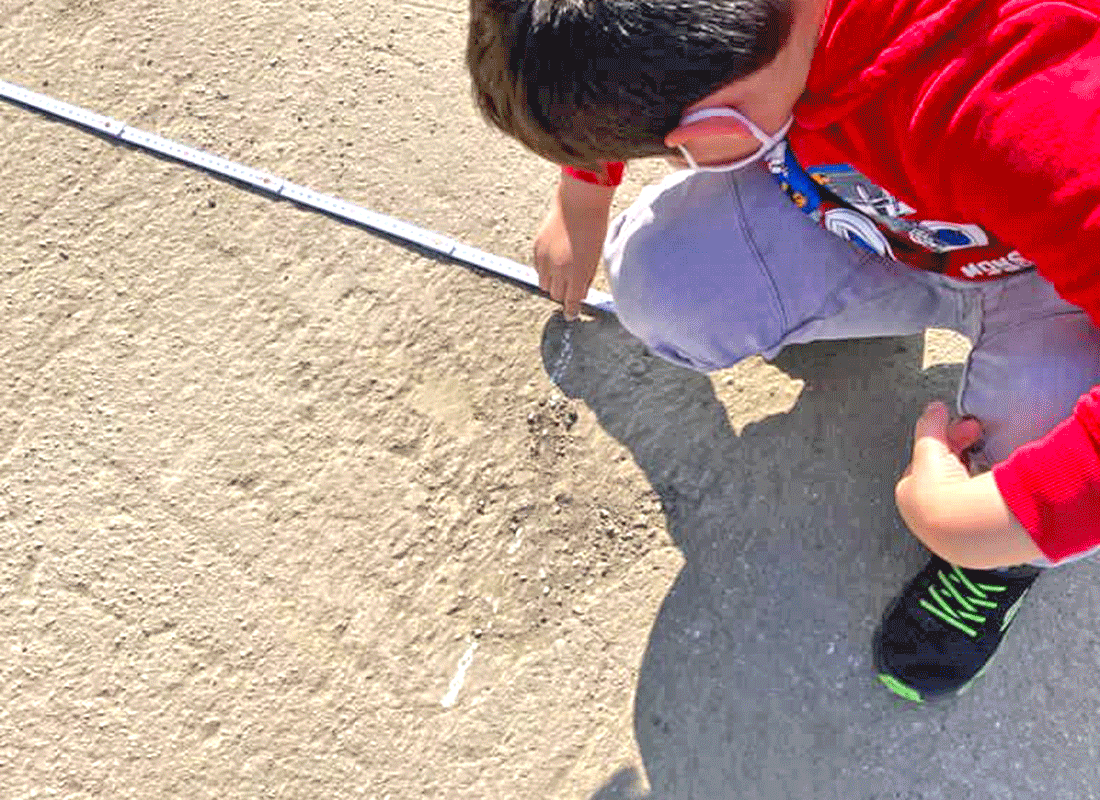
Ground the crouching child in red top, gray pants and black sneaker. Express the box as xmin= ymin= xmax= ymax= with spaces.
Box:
xmin=468 ymin=0 xmax=1100 ymax=701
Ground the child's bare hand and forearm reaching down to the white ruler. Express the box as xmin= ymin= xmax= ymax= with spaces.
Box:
xmin=535 ymin=175 xmax=615 ymax=319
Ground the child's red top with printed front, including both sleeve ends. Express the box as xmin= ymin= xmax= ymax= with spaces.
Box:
xmin=570 ymin=0 xmax=1100 ymax=561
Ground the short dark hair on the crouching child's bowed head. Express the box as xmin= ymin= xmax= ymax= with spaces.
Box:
xmin=466 ymin=0 xmax=791 ymax=168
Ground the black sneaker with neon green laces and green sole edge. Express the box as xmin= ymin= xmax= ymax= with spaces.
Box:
xmin=873 ymin=556 xmax=1043 ymax=703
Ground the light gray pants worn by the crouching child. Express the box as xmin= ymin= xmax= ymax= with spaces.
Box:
xmin=604 ymin=163 xmax=1100 ymax=555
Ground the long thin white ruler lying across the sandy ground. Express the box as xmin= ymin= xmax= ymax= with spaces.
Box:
xmin=0 ymin=80 xmax=615 ymax=314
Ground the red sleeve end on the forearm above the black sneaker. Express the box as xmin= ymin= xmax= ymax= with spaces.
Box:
xmin=993 ymin=387 xmax=1100 ymax=562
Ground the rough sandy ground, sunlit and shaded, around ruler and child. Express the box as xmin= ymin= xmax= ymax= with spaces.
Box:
xmin=0 ymin=0 xmax=1100 ymax=800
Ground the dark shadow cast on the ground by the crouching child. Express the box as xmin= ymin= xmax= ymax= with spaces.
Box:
xmin=543 ymin=317 xmax=1100 ymax=800
